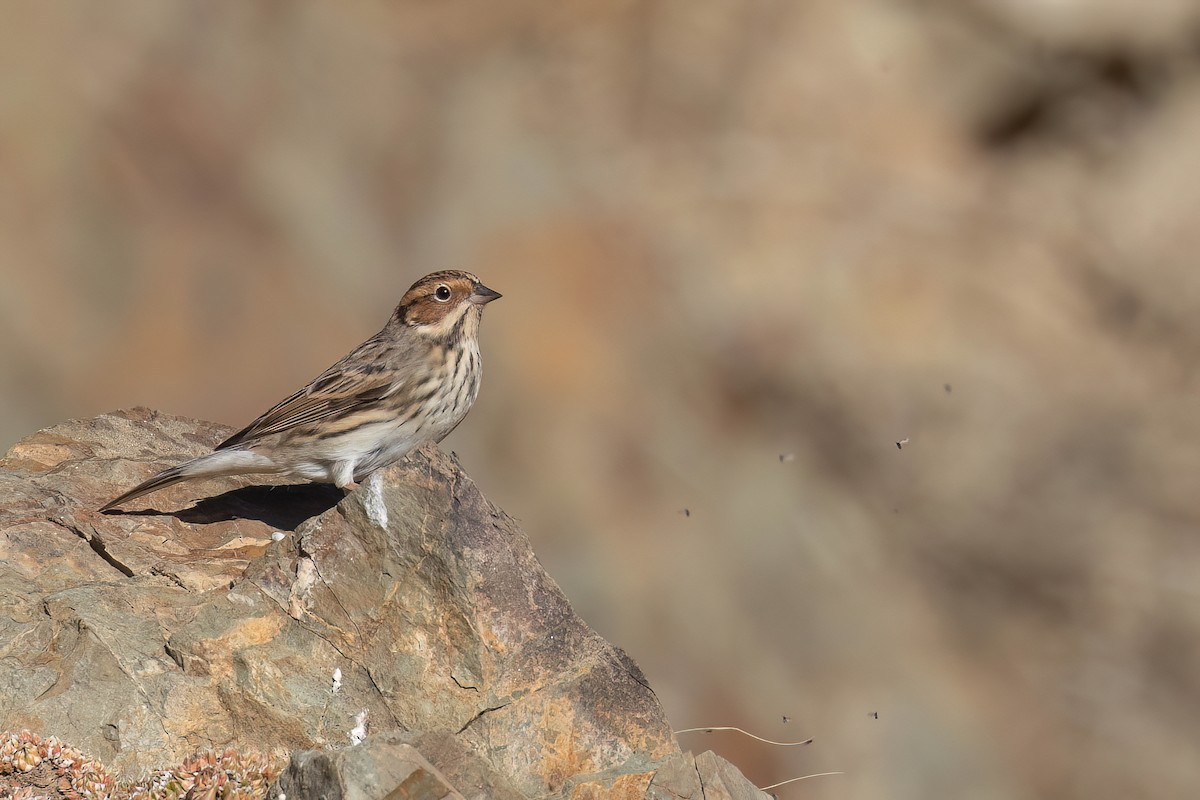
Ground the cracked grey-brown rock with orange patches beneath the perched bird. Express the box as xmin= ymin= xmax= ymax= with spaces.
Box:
xmin=0 ymin=409 xmax=763 ymax=798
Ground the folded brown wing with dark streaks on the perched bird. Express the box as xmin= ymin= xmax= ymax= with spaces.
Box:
xmin=216 ymin=339 xmax=413 ymax=450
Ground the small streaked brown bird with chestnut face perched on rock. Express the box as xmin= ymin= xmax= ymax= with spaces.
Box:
xmin=100 ymin=270 xmax=500 ymax=511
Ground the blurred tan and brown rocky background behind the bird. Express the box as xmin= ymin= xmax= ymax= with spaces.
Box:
xmin=0 ymin=0 xmax=1200 ymax=800
